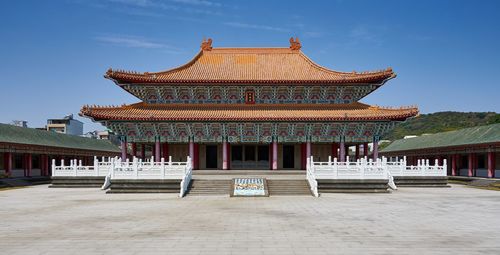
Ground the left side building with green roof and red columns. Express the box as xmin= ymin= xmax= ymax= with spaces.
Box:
xmin=0 ymin=124 xmax=120 ymax=177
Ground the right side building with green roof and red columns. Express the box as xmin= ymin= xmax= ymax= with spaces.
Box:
xmin=380 ymin=124 xmax=500 ymax=178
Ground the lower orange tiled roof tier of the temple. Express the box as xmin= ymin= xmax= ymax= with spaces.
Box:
xmin=80 ymin=102 xmax=418 ymax=121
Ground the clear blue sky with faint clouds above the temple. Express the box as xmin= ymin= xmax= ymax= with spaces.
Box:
xmin=0 ymin=0 xmax=500 ymax=131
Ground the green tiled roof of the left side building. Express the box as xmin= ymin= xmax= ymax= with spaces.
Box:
xmin=0 ymin=123 xmax=120 ymax=153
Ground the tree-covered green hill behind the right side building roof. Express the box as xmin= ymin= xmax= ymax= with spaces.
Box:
xmin=383 ymin=112 xmax=500 ymax=140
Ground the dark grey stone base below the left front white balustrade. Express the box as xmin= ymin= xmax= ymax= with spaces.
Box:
xmin=106 ymin=180 xmax=181 ymax=193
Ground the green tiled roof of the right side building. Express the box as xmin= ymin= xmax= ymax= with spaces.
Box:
xmin=380 ymin=123 xmax=500 ymax=153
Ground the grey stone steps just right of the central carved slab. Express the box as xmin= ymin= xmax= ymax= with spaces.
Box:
xmin=267 ymin=179 xmax=311 ymax=196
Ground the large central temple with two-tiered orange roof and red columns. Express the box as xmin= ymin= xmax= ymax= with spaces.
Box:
xmin=80 ymin=38 xmax=418 ymax=170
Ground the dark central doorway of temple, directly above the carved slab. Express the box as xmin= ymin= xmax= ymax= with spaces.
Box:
xmin=231 ymin=144 xmax=269 ymax=170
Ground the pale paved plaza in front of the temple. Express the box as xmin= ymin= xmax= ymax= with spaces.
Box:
xmin=0 ymin=185 xmax=500 ymax=255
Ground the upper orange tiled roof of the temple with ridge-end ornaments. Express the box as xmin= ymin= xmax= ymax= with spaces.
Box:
xmin=105 ymin=38 xmax=396 ymax=84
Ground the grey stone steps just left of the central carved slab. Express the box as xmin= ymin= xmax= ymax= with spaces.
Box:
xmin=188 ymin=179 xmax=232 ymax=196
